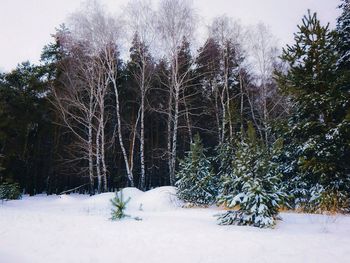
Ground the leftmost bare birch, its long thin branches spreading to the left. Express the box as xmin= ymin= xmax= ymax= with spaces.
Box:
xmin=52 ymin=29 xmax=96 ymax=194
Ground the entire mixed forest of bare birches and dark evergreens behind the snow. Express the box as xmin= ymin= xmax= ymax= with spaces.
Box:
xmin=0 ymin=0 xmax=350 ymax=220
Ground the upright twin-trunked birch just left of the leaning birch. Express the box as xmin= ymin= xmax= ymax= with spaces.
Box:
xmin=70 ymin=1 xmax=118 ymax=192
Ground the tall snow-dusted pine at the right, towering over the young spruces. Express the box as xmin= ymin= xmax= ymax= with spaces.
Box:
xmin=277 ymin=10 xmax=350 ymax=211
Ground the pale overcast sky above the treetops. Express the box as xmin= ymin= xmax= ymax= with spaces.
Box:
xmin=0 ymin=0 xmax=340 ymax=71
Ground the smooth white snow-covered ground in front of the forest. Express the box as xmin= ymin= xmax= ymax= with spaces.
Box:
xmin=0 ymin=187 xmax=350 ymax=263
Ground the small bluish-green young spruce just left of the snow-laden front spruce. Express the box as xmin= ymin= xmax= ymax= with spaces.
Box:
xmin=175 ymin=134 xmax=217 ymax=205
